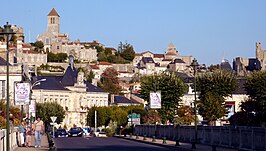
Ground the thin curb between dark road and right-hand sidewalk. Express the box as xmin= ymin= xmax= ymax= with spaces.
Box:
xmin=113 ymin=136 xmax=193 ymax=151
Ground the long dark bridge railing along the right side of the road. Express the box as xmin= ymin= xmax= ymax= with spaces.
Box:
xmin=134 ymin=125 xmax=266 ymax=151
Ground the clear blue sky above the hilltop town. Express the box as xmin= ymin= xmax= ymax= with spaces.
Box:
xmin=0 ymin=0 xmax=266 ymax=65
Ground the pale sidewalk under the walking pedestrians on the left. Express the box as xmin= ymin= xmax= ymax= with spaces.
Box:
xmin=15 ymin=135 xmax=49 ymax=151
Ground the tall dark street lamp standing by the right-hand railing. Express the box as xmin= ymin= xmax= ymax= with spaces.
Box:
xmin=190 ymin=58 xmax=199 ymax=149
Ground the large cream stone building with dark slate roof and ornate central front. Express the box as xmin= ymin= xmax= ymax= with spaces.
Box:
xmin=33 ymin=60 xmax=109 ymax=128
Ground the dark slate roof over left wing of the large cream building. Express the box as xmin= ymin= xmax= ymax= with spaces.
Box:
xmin=32 ymin=76 xmax=69 ymax=91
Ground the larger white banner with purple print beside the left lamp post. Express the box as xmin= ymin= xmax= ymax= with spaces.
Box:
xmin=15 ymin=82 xmax=30 ymax=105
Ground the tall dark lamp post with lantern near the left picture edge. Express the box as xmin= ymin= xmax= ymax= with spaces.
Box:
xmin=0 ymin=22 xmax=15 ymax=151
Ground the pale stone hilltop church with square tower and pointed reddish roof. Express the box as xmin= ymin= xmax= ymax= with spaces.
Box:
xmin=37 ymin=8 xmax=97 ymax=62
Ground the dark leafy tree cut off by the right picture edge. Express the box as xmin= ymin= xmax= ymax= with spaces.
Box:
xmin=245 ymin=71 xmax=266 ymax=125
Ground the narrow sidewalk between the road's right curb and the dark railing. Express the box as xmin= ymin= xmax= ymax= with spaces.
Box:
xmin=116 ymin=135 xmax=238 ymax=151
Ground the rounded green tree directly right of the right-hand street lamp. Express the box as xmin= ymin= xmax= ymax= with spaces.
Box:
xmin=194 ymin=70 xmax=236 ymax=123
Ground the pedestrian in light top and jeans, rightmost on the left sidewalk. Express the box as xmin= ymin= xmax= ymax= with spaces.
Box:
xmin=33 ymin=117 xmax=44 ymax=148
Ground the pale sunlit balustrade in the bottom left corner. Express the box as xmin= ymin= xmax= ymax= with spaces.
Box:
xmin=0 ymin=128 xmax=18 ymax=151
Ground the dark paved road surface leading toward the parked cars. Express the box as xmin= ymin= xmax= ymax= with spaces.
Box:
xmin=54 ymin=137 xmax=175 ymax=151
